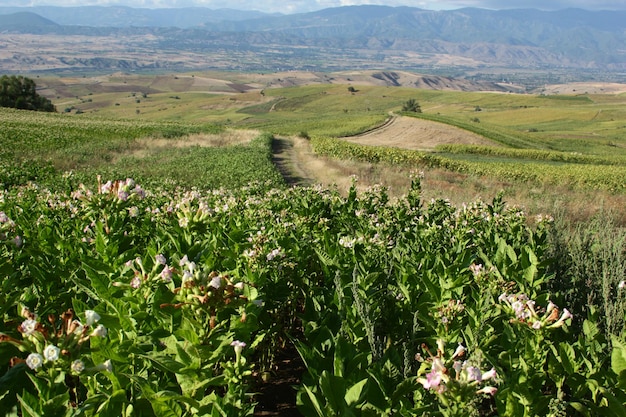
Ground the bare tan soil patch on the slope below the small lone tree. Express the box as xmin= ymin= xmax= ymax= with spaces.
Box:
xmin=344 ymin=116 xmax=496 ymax=150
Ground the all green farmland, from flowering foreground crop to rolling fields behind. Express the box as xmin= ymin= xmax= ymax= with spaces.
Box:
xmin=0 ymin=73 xmax=626 ymax=417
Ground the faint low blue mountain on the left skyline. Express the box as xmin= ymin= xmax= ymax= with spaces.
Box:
xmin=0 ymin=6 xmax=271 ymax=28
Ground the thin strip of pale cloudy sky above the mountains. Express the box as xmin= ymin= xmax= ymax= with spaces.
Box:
xmin=0 ymin=0 xmax=626 ymax=14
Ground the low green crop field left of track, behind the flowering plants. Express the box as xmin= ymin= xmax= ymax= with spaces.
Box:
xmin=0 ymin=109 xmax=283 ymax=188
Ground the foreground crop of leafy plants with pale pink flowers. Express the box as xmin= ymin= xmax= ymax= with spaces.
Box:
xmin=0 ymin=179 xmax=626 ymax=417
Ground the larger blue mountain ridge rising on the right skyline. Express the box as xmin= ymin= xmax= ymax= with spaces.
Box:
xmin=196 ymin=6 xmax=626 ymax=66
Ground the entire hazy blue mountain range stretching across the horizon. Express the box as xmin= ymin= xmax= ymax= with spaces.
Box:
xmin=0 ymin=6 xmax=626 ymax=76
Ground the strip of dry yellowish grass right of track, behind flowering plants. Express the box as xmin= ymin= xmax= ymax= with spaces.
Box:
xmin=292 ymin=138 xmax=626 ymax=227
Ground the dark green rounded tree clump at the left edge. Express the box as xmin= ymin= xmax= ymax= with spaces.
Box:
xmin=0 ymin=75 xmax=56 ymax=112
